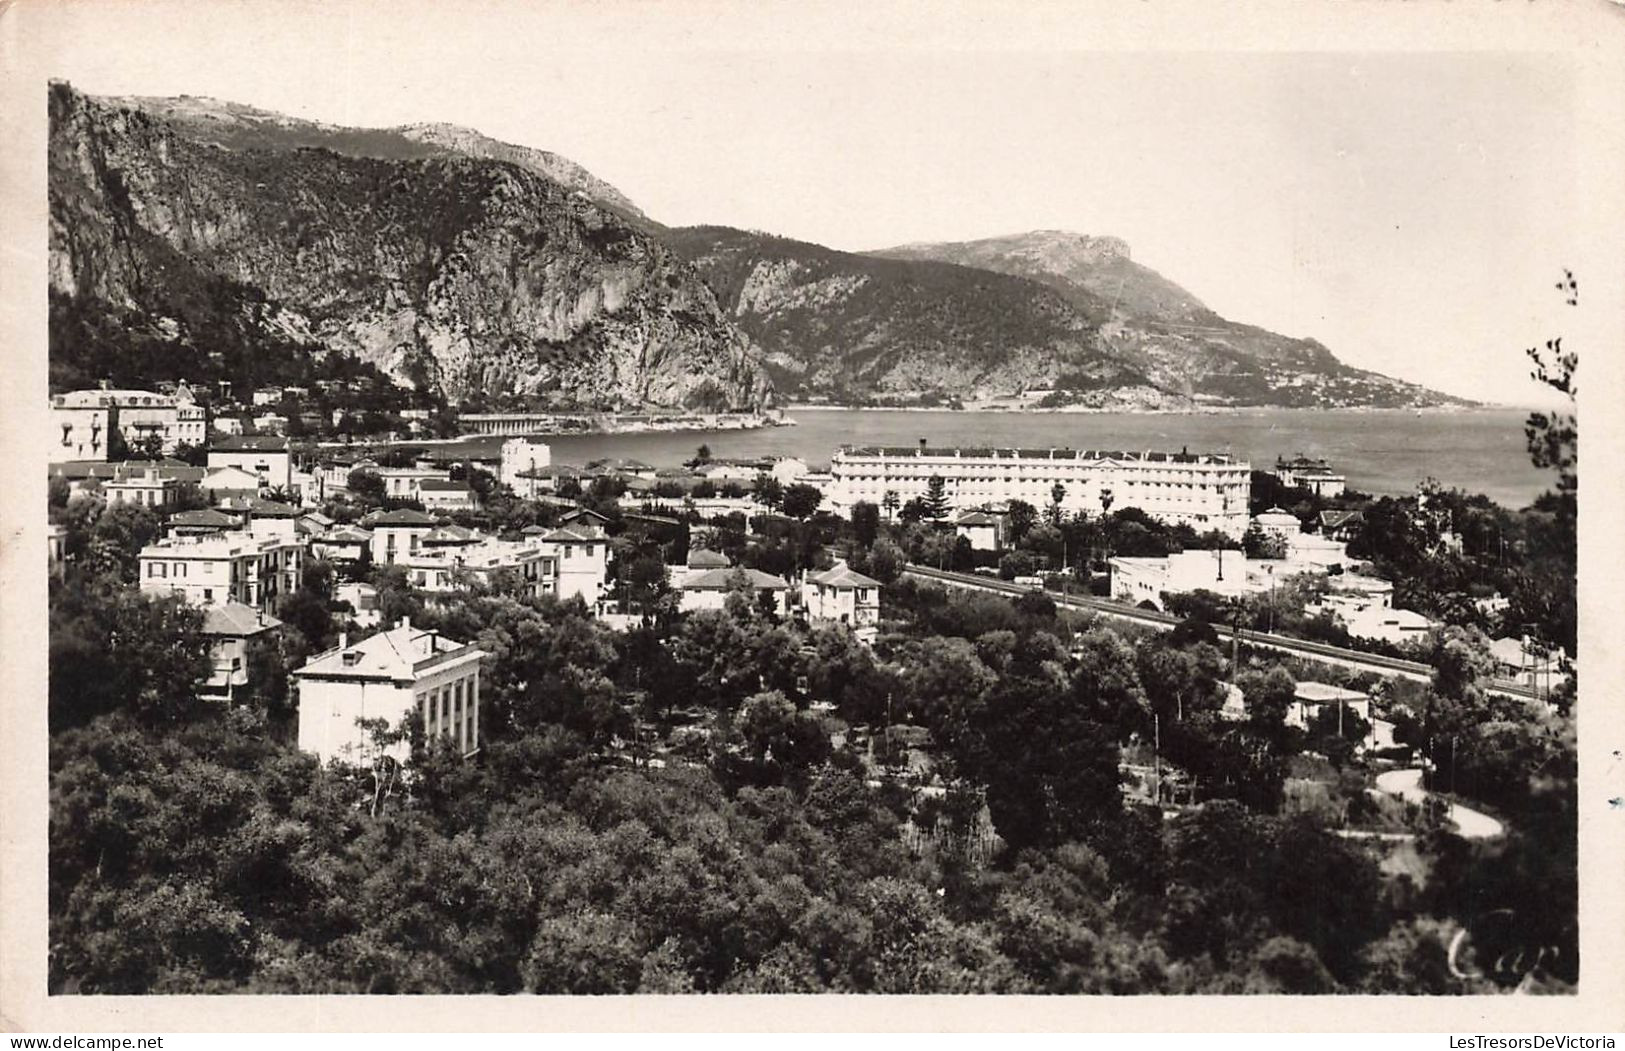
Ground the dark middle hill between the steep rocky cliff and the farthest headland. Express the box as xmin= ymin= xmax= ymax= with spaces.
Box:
xmin=663 ymin=226 xmax=1170 ymax=408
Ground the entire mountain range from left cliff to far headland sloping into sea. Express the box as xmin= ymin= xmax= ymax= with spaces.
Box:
xmin=50 ymin=84 xmax=1464 ymax=409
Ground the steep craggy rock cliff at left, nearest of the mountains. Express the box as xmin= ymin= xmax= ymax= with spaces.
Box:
xmin=49 ymin=84 xmax=772 ymax=408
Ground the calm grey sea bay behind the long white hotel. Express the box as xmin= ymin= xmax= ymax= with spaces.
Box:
xmin=412 ymin=406 xmax=1555 ymax=508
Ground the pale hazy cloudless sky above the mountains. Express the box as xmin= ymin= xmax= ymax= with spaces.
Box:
xmin=34 ymin=3 xmax=1580 ymax=403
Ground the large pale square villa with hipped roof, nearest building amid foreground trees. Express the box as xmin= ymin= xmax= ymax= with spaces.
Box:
xmin=294 ymin=621 xmax=486 ymax=762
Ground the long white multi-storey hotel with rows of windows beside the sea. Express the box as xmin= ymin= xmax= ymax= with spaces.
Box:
xmin=826 ymin=442 xmax=1253 ymax=538
